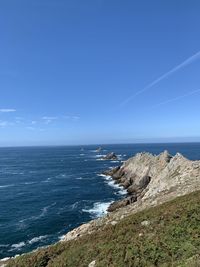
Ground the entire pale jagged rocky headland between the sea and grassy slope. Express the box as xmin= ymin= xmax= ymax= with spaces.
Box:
xmin=60 ymin=151 xmax=200 ymax=247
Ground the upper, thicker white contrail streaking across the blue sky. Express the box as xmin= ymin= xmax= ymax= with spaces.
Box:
xmin=120 ymin=51 xmax=200 ymax=106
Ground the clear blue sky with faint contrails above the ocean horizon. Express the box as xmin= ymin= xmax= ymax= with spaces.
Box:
xmin=0 ymin=0 xmax=200 ymax=146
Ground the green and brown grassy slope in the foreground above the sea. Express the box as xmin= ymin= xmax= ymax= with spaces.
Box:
xmin=8 ymin=191 xmax=200 ymax=267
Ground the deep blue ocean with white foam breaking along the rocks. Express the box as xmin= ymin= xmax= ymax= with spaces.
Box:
xmin=0 ymin=143 xmax=200 ymax=259
